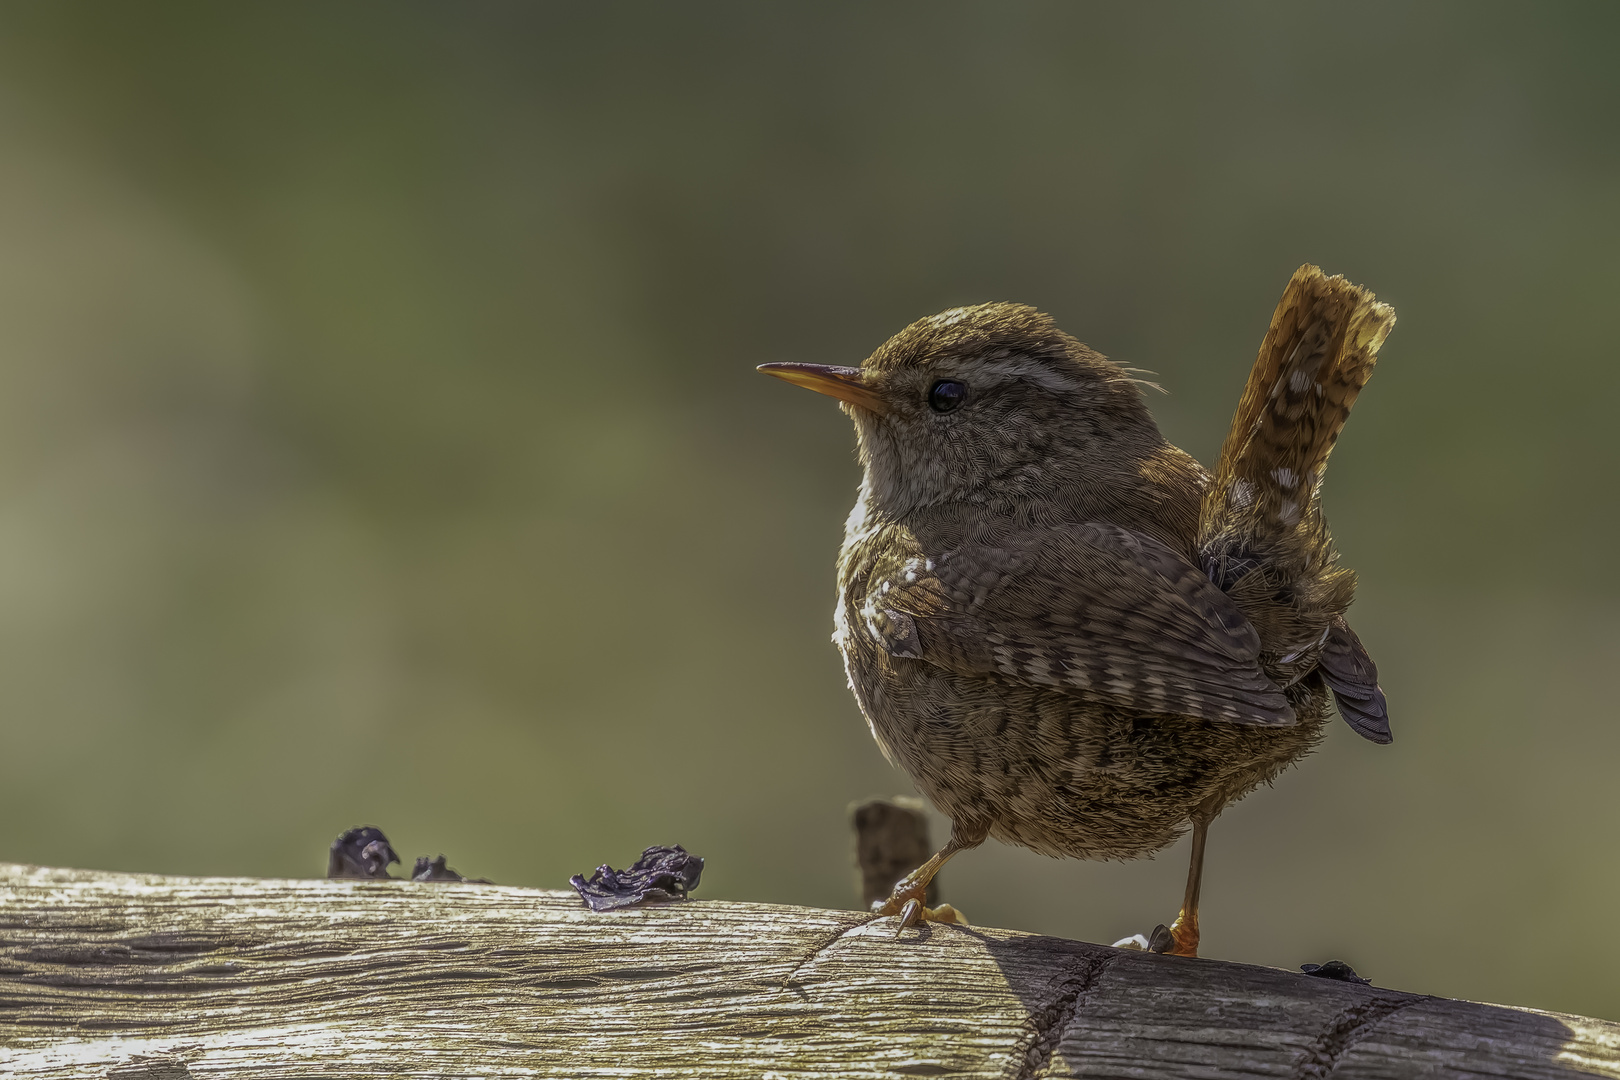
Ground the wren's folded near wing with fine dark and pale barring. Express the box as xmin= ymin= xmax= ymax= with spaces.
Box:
xmin=860 ymin=523 xmax=1294 ymax=727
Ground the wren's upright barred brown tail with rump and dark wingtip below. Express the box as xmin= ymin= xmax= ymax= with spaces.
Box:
xmin=1199 ymin=266 xmax=1395 ymax=742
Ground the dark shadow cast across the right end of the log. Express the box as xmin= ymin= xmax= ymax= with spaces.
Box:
xmin=952 ymin=928 xmax=1600 ymax=1080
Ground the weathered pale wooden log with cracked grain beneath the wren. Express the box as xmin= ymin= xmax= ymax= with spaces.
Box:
xmin=0 ymin=865 xmax=1620 ymax=1080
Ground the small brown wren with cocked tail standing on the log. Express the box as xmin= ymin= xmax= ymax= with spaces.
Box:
xmin=760 ymin=264 xmax=1395 ymax=957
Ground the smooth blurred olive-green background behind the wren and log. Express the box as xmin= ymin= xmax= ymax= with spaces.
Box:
xmin=0 ymin=3 xmax=1620 ymax=1018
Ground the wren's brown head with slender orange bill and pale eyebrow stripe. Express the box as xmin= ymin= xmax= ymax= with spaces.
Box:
xmin=760 ymin=303 xmax=1162 ymax=513
